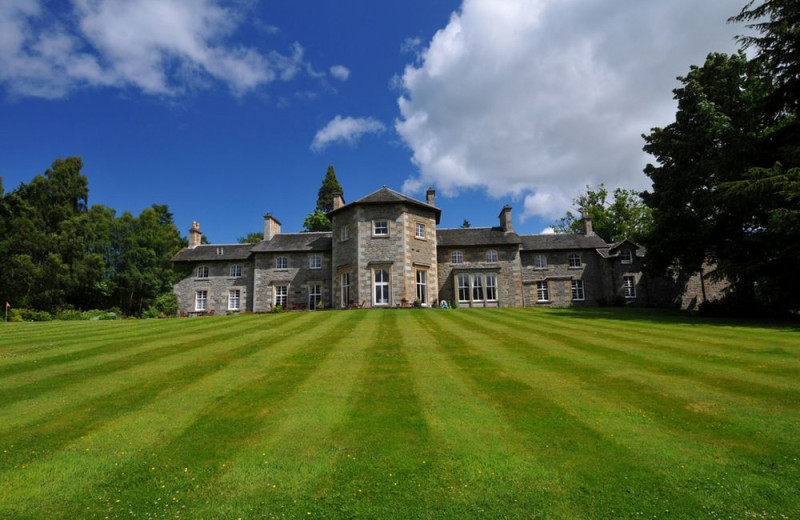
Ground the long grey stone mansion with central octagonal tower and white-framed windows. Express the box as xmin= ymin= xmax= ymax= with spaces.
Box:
xmin=173 ymin=187 xmax=692 ymax=316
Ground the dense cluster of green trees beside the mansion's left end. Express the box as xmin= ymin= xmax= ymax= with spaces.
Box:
xmin=0 ymin=157 xmax=186 ymax=316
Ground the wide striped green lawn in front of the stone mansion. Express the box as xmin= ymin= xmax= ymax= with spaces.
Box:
xmin=0 ymin=309 xmax=800 ymax=519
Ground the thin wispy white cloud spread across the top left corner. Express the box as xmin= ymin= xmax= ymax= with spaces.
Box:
xmin=0 ymin=0 xmax=304 ymax=98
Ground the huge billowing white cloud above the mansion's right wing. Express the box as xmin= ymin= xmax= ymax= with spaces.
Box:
xmin=395 ymin=0 xmax=744 ymax=218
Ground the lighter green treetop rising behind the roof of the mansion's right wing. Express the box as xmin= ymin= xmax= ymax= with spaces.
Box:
xmin=553 ymin=183 xmax=652 ymax=243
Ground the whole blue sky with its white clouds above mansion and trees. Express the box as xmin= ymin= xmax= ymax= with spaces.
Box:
xmin=0 ymin=0 xmax=746 ymax=243
